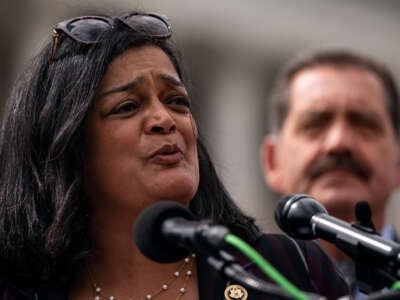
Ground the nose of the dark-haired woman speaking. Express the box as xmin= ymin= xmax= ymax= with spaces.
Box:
xmin=145 ymin=101 xmax=176 ymax=134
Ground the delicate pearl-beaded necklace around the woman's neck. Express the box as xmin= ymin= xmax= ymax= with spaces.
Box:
xmin=87 ymin=253 xmax=196 ymax=300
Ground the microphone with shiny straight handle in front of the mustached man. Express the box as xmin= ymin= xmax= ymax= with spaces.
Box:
xmin=275 ymin=194 xmax=400 ymax=265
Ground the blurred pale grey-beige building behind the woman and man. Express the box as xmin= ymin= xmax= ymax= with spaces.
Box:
xmin=0 ymin=0 xmax=400 ymax=231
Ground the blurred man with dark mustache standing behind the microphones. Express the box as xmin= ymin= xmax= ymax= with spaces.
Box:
xmin=261 ymin=51 xmax=400 ymax=296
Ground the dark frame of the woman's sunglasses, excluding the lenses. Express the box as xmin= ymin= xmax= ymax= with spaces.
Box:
xmin=50 ymin=13 xmax=172 ymax=61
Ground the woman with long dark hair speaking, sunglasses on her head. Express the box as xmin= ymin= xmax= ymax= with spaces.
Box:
xmin=0 ymin=12 xmax=347 ymax=300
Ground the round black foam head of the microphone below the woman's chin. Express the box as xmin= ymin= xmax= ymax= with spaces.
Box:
xmin=133 ymin=201 xmax=194 ymax=263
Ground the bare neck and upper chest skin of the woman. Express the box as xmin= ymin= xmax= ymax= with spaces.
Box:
xmin=70 ymin=212 xmax=198 ymax=300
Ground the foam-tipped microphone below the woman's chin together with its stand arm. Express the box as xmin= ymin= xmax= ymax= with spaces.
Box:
xmin=133 ymin=201 xmax=321 ymax=299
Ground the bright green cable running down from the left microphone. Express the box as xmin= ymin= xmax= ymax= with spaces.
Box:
xmin=224 ymin=233 xmax=309 ymax=300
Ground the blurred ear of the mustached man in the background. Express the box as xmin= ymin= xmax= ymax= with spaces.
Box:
xmin=260 ymin=134 xmax=282 ymax=191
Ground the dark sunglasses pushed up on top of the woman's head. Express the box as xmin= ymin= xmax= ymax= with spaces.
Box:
xmin=50 ymin=13 xmax=172 ymax=60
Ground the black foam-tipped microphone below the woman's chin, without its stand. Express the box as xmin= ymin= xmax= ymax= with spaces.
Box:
xmin=133 ymin=201 xmax=229 ymax=263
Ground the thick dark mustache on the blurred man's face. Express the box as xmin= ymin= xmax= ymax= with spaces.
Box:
xmin=307 ymin=153 xmax=371 ymax=180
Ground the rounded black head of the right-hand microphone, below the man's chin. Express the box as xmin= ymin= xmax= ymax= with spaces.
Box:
xmin=275 ymin=194 xmax=328 ymax=239
